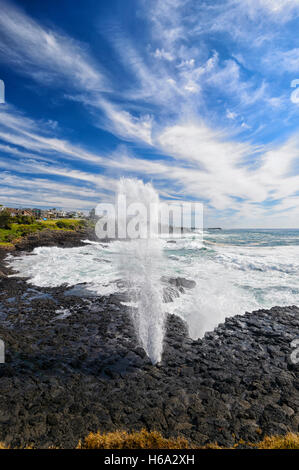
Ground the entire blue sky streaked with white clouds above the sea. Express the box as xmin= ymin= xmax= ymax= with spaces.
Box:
xmin=0 ymin=0 xmax=299 ymax=228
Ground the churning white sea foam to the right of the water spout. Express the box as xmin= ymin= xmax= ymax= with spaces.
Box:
xmin=163 ymin=244 xmax=299 ymax=338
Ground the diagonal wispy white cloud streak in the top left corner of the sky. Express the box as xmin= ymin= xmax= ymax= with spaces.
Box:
xmin=0 ymin=1 xmax=106 ymax=90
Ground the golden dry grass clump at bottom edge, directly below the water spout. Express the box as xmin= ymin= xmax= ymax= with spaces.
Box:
xmin=77 ymin=429 xmax=191 ymax=449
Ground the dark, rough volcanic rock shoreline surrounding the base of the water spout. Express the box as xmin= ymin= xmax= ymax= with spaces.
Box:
xmin=0 ymin=237 xmax=299 ymax=448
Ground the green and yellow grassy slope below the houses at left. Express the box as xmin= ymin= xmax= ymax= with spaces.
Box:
xmin=0 ymin=210 xmax=87 ymax=245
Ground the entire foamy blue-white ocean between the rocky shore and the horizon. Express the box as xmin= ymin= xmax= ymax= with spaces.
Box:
xmin=9 ymin=229 xmax=299 ymax=348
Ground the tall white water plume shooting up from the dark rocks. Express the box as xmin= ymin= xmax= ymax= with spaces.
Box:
xmin=118 ymin=178 xmax=165 ymax=364
